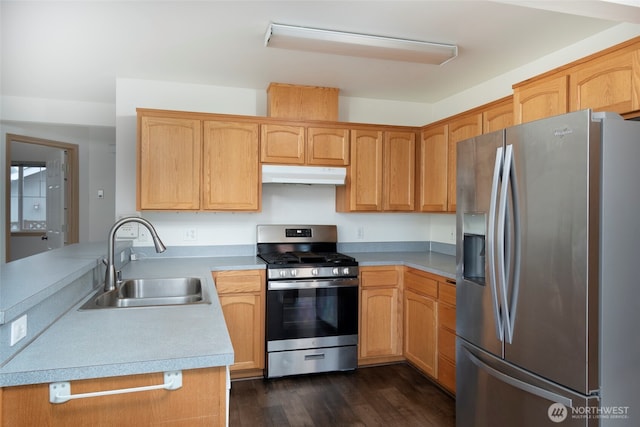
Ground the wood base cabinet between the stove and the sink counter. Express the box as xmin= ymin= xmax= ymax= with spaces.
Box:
xmin=212 ymin=270 xmax=265 ymax=378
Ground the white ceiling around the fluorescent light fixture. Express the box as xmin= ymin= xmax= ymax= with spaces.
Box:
xmin=0 ymin=0 xmax=640 ymax=104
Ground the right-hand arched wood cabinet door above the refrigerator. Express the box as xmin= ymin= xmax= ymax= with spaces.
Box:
xmin=569 ymin=49 xmax=640 ymax=114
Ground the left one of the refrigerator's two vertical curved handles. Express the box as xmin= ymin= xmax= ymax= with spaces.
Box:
xmin=487 ymin=147 xmax=504 ymax=341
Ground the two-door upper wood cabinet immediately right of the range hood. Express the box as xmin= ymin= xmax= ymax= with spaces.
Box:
xmin=336 ymin=128 xmax=416 ymax=212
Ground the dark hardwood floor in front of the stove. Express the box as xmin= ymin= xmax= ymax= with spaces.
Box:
xmin=229 ymin=364 xmax=455 ymax=427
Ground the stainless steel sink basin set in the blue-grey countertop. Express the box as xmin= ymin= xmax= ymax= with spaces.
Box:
xmin=80 ymin=277 xmax=208 ymax=310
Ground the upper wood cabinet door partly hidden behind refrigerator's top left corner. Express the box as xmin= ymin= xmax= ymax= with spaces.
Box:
xmin=447 ymin=113 xmax=482 ymax=212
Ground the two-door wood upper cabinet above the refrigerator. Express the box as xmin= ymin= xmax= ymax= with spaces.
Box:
xmin=513 ymin=38 xmax=640 ymax=124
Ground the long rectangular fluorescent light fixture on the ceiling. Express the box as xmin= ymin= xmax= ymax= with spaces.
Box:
xmin=264 ymin=23 xmax=458 ymax=65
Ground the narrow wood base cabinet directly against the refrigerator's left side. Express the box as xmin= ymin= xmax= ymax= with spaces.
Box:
xmin=438 ymin=279 xmax=456 ymax=393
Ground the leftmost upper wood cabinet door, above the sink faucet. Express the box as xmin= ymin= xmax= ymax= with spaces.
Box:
xmin=137 ymin=116 xmax=202 ymax=210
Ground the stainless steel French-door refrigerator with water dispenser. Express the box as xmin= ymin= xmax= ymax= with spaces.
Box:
xmin=456 ymin=110 xmax=640 ymax=427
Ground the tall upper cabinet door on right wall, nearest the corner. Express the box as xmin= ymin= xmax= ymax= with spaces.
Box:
xmin=417 ymin=125 xmax=449 ymax=212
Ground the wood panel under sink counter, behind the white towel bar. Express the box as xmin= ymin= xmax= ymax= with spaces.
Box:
xmin=0 ymin=366 xmax=227 ymax=427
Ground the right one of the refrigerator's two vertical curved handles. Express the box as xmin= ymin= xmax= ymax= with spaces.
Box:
xmin=496 ymin=144 xmax=513 ymax=344
